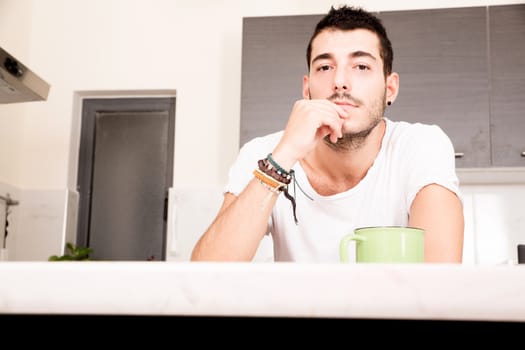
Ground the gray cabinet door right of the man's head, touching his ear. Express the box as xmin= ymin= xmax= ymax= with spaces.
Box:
xmin=379 ymin=7 xmax=491 ymax=167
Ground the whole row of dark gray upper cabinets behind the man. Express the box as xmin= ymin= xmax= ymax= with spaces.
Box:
xmin=240 ymin=4 xmax=525 ymax=168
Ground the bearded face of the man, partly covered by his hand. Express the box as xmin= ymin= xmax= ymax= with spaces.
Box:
xmin=303 ymin=29 xmax=386 ymax=141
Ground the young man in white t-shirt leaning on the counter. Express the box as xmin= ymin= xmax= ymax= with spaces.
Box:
xmin=191 ymin=6 xmax=464 ymax=263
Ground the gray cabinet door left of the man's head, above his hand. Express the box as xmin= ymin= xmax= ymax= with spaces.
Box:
xmin=240 ymin=15 xmax=322 ymax=146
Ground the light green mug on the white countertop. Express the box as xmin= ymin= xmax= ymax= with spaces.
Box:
xmin=339 ymin=226 xmax=425 ymax=263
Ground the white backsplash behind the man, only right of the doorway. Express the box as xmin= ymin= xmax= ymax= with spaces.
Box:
xmin=167 ymin=174 xmax=525 ymax=264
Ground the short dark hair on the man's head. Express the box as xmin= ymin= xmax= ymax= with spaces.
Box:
xmin=306 ymin=5 xmax=394 ymax=77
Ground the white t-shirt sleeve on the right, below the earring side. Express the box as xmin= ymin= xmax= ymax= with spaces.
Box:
xmin=406 ymin=124 xmax=462 ymax=208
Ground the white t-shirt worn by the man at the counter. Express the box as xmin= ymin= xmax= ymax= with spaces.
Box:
xmin=225 ymin=118 xmax=460 ymax=262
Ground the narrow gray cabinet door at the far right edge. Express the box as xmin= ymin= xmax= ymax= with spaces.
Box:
xmin=489 ymin=5 xmax=525 ymax=166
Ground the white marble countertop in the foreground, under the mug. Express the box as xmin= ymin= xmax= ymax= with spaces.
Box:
xmin=0 ymin=261 xmax=525 ymax=322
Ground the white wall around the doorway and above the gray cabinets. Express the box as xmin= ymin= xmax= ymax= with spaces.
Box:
xmin=0 ymin=0 xmax=522 ymax=257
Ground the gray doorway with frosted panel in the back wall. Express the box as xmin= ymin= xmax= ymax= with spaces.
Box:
xmin=77 ymin=97 xmax=175 ymax=261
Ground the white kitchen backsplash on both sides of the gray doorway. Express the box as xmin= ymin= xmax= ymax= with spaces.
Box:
xmin=0 ymin=172 xmax=525 ymax=264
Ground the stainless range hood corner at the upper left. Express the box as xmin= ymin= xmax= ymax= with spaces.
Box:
xmin=0 ymin=47 xmax=49 ymax=103
